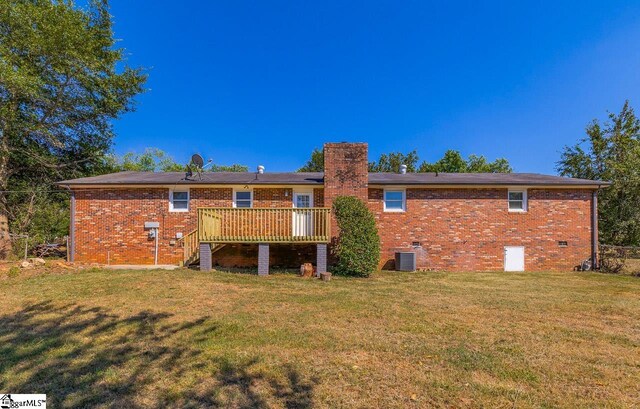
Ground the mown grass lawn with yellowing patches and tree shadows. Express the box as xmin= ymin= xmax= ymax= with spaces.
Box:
xmin=0 ymin=270 xmax=640 ymax=408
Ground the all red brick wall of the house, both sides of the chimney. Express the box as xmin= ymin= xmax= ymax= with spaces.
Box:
xmin=75 ymin=183 xmax=591 ymax=271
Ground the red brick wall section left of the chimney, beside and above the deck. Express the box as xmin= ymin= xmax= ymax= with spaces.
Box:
xmin=75 ymin=188 xmax=293 ymax=264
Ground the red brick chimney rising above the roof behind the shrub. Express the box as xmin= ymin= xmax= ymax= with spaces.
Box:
xmin=324 ymin=142 xmax=369 ymax=207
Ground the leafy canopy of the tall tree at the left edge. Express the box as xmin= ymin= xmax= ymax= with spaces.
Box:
xmin=0 ymin=0 xmax=146 ymax=255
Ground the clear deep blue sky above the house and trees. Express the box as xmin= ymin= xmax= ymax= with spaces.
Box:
xmin=111 ymin=0 xmax=640 ymax=173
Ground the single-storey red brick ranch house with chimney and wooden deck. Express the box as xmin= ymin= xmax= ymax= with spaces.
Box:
xmin=59 ymin=143 xmax=607 ymax=274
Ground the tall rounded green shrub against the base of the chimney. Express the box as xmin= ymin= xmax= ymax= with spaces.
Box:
xmin=333 ymin=196 xmax=380 ymax=277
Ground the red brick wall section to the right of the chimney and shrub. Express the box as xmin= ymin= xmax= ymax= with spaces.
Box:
xmin=368 ymin=189 xmax=591 ymax=271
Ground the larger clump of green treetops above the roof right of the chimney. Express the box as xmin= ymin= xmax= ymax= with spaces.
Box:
xmin=418 ymin=150 xmax=512 ymax=173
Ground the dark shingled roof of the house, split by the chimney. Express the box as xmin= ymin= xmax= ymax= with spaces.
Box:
xmin=58 ymin=171 xmax=609 ymax=188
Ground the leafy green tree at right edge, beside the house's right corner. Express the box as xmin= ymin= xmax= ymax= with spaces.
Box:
xmin=557 ymin=101 xmax=640 ymax=246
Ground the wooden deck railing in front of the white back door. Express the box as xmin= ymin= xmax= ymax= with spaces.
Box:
xmin=198 ymin=207 xmax=331 ymax=243
